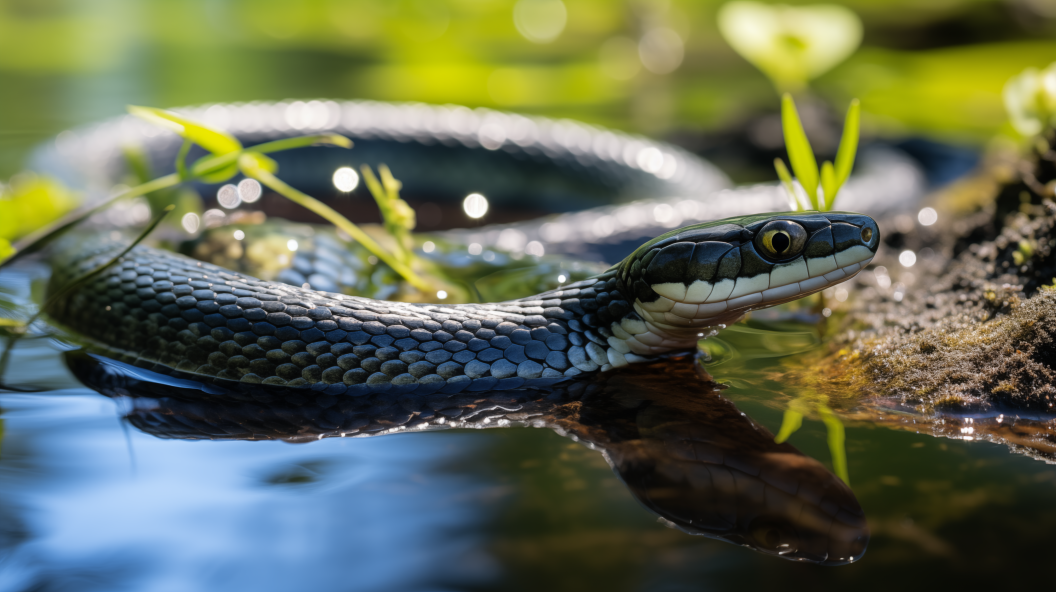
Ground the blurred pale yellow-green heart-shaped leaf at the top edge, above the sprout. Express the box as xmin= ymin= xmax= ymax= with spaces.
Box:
xmin=718 ymin=1 xmax=862 ymax=92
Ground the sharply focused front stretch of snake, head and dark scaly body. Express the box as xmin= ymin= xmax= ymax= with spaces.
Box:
xmin=50 ymin=213 xmax=880 ymax=395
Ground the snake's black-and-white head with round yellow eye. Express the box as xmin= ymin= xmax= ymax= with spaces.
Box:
xmin=618 ymin=212 xmax=880 ymax=354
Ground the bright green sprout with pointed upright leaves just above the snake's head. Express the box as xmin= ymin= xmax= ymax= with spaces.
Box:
xmin=774 ymin=93 xmax=862 ymax=212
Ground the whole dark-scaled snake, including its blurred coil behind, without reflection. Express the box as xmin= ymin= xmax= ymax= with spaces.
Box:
xmin=28 ymin=101 xmax=880 ymax=395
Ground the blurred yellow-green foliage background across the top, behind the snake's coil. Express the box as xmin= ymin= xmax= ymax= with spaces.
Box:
xmin=0 ymin=0 xmax=1056 ymax=175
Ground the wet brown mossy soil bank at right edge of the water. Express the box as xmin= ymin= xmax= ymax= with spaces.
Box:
xmin=814 ymin=138 xmax=1056 ymax=421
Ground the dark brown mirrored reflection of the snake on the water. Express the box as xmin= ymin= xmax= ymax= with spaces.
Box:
xmin=67 ymin=351 xmax=869 ymax=565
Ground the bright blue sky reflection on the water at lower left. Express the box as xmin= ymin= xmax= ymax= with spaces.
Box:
xmin=0 ymin=358 xmax=497 ymax=590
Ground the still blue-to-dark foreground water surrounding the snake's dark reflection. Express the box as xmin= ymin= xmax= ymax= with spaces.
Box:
xmin=6 ymin=263 xmax=1056 ymax=592
